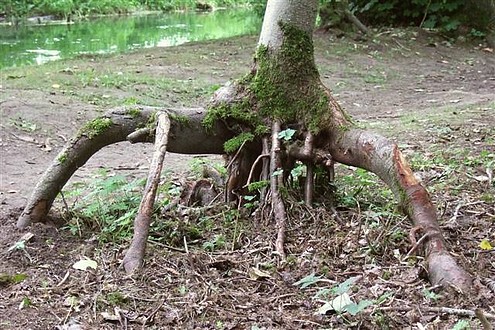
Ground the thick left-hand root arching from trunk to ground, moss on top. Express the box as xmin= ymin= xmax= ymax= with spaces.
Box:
xmin=17 ymin=107 xmax=230 ymax=228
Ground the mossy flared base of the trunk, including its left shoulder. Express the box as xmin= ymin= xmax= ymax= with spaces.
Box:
xmin=203 ymin=23 xmax=332 ymax=153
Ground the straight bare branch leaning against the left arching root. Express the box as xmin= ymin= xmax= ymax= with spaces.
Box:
xmin=122 ymin=112 xmax=170 ymax=273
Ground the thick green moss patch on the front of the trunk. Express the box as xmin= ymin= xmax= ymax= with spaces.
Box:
xmin=254 ymin=23 xmax=331 ymax=133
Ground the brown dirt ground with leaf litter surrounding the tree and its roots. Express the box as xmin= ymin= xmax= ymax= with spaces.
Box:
xmin=0 ymin=30 xmax=495 ymax=329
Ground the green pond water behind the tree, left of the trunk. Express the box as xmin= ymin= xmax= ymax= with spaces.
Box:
xmin=0 ymin=9 xmax=261 ymax=69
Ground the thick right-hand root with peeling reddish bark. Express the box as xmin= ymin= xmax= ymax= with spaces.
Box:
xmin=328 ymin=128 xmax=472 ymax=290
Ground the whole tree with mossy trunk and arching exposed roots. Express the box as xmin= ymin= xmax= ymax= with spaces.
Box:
xmin=18 ymin=0 xmax=471 ymax=289
